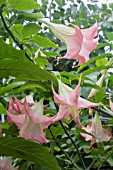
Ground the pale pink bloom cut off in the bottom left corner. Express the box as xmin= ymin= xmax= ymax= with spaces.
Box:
xmin=0 ymin=157 xmax=18 ymax=170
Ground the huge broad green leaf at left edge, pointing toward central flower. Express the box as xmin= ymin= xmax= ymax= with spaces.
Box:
xmin=0 ymin=40 xmax=56 ymax=82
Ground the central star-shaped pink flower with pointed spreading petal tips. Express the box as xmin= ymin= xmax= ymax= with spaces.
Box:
xmin=52 ymin=79 xmax=99 ymax=126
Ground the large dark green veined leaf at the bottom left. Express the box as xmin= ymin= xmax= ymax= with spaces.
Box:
xmin=0 ymin=137 xmax=60 ymax=170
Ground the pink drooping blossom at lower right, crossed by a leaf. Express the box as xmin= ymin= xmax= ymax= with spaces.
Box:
xmin=81 ymin=113 xmax=112 ymax=147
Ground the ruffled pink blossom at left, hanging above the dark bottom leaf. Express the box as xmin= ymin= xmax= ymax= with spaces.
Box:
xmin=7 ymin=96 xmax=52 ymax=143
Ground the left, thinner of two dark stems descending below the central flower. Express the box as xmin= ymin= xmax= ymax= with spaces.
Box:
xmin=48 ymin=126 xmax=79 ymax=170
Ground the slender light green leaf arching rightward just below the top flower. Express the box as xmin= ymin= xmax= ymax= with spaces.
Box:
xmin=77 ymin=53 xmax=112 ymax=73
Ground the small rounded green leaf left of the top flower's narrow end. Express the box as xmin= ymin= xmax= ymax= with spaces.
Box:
xmin=22 ymin=23 xmax=40 ymax=37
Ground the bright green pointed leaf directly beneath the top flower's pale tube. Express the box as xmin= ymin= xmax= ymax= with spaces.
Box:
xmin=32 ymin=35 xmax=59 ymax=48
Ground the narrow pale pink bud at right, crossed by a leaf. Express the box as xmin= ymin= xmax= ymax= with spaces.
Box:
xmin=88 ymin=74 xmax=105 ymax=98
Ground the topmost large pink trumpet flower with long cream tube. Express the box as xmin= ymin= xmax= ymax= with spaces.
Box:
xmin=42 ymin=19 xmax=98 ymax=65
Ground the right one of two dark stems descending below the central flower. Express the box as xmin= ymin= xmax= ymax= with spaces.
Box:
xmin=59 ymin=120 xmax=87 ymax=170
